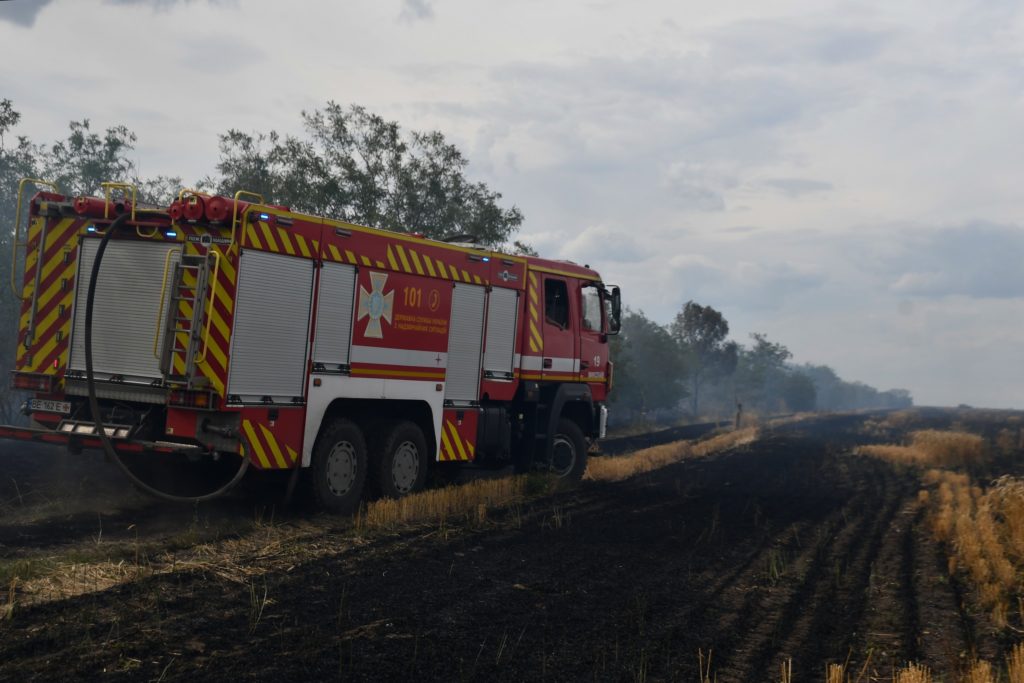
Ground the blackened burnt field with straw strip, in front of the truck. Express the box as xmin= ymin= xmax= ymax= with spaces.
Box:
xmin=0 ymin=412 xmax=1020 ymax=681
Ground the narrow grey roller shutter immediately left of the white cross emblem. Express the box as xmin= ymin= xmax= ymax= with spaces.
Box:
xmin=313 ymin=263 xmax=355 ymax=370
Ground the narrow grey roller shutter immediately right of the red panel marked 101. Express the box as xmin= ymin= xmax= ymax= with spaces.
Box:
xmin=444 ymin=284 xmax=484 ymax=404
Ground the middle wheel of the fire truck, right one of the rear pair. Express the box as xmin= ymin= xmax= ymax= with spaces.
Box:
xmin=372 ymin=420 xmax=429 ymax=498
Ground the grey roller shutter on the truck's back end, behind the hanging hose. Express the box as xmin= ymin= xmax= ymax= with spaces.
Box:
xmin=69 ymin=240 xmax=180 ymax=383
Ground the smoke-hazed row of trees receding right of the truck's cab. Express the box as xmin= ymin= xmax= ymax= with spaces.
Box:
xmin=611 ymin=301 xmax=913 ymax=424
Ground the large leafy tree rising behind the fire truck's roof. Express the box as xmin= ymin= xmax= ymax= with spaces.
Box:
xmin=209 ymin=102 xmax=528 ymax=249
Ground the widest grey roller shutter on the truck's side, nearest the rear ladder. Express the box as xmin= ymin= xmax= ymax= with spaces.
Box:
xmin=227 ymin=250 xmax=313 ymax=402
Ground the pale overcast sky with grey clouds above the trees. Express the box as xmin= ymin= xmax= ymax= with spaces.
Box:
xmin=0 ymin=0 xmax=1024 ymax=408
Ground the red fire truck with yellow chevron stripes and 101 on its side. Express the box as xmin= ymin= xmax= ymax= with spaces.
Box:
xmin=0 ymin=179 xmax=621 ymax=512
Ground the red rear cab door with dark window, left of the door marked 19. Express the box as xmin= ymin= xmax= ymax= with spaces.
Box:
xmin=541 ymin=273 xmax=580 ymax=382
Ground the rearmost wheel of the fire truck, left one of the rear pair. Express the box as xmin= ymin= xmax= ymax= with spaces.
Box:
xmin=303 ymin=418 xmax=368 ymax=514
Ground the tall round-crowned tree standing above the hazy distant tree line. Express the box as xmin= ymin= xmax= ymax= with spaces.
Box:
xmin=672 ymin=300 xmax=739 ymax=417
